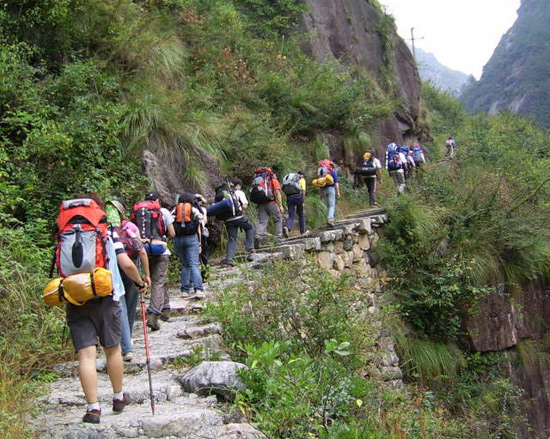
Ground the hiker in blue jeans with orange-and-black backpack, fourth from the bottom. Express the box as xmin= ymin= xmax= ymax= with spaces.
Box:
xmin=174 ymin=193 xmax=207 ymax=299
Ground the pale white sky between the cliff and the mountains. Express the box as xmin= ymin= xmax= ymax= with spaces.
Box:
xmin=380 ymin=0 xmax=520 ymax=79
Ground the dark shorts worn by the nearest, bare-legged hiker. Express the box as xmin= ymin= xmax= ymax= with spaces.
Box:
xmin=66 ymin=296 xmax=122 ymax=352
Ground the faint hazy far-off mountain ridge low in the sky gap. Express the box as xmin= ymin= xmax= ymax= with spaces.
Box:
xmin=415 ymin=49 xmax=468 ymax=96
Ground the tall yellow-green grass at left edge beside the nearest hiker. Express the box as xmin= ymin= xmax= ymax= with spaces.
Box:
xmin=0 ymin=229 xmax=70 ymax=439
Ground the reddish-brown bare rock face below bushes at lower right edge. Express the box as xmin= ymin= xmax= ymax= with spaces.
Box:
xmin=466 ymin=279 xmax=550 ymax=439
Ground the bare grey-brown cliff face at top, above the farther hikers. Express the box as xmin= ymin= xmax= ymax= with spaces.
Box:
xmin=302 ymin=0 xmax=421 ymax=162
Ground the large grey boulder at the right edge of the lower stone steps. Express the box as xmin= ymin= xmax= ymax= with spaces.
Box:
xmin=179 ymin=361 xmax=248 ymax=401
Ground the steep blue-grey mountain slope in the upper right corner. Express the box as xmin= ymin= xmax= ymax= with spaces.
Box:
xmin=460 ymin=0 xmax=550 ymax=128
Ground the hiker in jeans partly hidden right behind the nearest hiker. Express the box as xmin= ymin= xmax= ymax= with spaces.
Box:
xmin=105 ymin=200 xmax=151 ymax=361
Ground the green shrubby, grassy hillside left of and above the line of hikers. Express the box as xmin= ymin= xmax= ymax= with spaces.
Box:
xmin=0 ymin=0 xmax=394 ymax=438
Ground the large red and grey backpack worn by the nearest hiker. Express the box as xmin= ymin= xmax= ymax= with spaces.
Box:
xmin=52 ymin=198 xmax=109 ymax=277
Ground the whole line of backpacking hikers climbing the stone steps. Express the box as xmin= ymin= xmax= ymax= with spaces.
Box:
xmin=44 ymin=143 xmax=436 ymax=423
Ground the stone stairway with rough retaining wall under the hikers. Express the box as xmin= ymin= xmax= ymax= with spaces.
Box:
xmin=30 ymin=209 xmax=402 ymax=439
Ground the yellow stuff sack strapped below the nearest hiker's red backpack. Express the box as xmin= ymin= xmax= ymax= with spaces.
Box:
xmin=42 ymin=267 xmax=113 ymax=306
